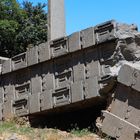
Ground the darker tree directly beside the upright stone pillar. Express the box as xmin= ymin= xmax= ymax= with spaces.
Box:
xmin=17 ymin=1 xmax=47 ymax=53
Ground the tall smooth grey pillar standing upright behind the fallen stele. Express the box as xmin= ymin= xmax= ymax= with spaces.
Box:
xmin=48 ymin=0 xmax=66 ymax=41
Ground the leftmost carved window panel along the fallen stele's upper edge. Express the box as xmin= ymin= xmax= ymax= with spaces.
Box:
xmin=12 ymin=53 xmax=27 ymax=70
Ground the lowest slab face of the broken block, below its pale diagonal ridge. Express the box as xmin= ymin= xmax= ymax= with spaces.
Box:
xmin=102 ymin=111 xmax=140 ymax=140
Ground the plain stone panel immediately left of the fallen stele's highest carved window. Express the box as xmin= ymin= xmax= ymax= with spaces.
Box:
xmin=80 ymin=27 xmax=96 ymax=48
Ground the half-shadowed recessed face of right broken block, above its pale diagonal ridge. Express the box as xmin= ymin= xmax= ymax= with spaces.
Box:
xmin=100 ymin=77 xmax=140 ymax=133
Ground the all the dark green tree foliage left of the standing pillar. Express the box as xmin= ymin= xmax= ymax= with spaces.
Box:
xmin=0 ymin=0 xmax=47 ymax=57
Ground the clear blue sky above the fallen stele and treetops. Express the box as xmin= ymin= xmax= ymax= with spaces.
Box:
xmin=18 ymin=0 xmax=140 ymax=35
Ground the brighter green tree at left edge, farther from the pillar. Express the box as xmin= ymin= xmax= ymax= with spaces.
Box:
xmin=0 ymin=0 xmax=20 ymax=57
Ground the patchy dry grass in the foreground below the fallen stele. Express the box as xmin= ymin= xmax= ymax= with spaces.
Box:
xmin=0 ymin=118 xmax=104 ymax=140
